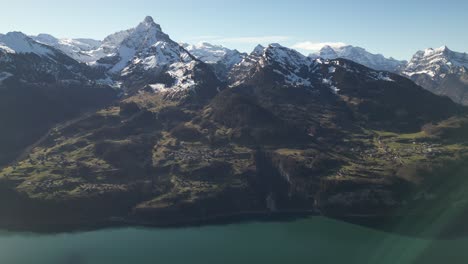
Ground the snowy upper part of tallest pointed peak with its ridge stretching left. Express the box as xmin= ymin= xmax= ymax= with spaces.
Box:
xmin=33 ymin=17 xmax=190 ymax=74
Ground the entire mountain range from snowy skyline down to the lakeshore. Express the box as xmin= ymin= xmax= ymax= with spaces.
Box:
xmin=0 ymin=17 xmax=468 ymax=235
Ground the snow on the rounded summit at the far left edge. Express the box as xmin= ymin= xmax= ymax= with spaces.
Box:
xmin=0 ymin=32 xmax=54 ymax=56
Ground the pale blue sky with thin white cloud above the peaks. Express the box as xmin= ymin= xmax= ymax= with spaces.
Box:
xmin=0 ymin=0 xmax=468 ymax=60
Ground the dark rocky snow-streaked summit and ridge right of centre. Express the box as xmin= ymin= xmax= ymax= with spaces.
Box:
xmin=225 ymin=44 xmax=394 ymax=94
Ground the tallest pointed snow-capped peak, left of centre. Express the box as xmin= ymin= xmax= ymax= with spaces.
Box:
xmin=103 ymin=17 xmax=222 ymax=95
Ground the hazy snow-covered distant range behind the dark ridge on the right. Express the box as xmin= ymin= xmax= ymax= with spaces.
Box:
xmin=310 ymin=46 xmax=468 ymax=105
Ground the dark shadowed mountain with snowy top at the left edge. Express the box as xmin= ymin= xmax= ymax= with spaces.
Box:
xmin=0 ymin=32 xmax=117 ymax=165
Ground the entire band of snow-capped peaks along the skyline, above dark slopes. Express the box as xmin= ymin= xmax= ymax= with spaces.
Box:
xmin=4 ymin=17 xmax=468 ymax=104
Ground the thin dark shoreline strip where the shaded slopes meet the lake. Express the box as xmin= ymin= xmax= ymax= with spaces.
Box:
xmin=0 ymin=210 xmax=468 ymax=240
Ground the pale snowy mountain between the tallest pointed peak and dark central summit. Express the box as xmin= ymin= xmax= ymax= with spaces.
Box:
xmin=182 ymin=42 xmax=247 ymax=81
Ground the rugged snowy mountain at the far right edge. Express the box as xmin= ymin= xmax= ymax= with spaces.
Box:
xmin=402 ymin=46 xmax=468 ymax=105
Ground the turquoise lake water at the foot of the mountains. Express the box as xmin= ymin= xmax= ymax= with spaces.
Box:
xmin=0 ymin=217 xmax=468 ymax=264
